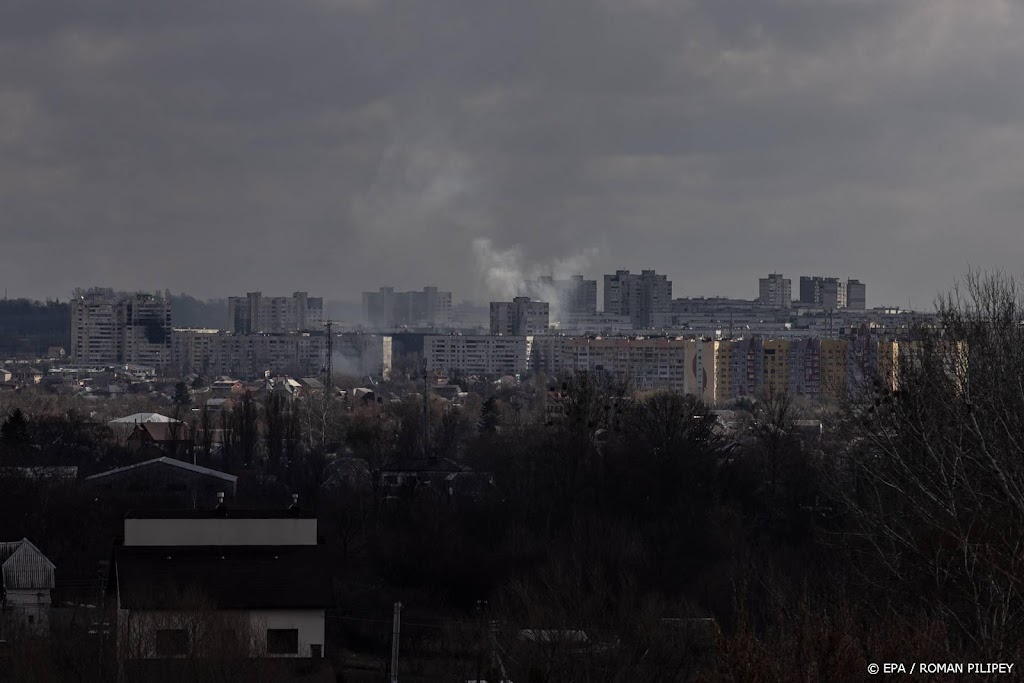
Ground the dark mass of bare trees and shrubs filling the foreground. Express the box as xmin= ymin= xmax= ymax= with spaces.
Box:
xmin=0 ymin=275 xmax=1024 ymax=682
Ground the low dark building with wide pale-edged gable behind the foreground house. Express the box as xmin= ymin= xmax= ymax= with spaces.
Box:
xmin=83 ymin=457 xmax=239 ymax=506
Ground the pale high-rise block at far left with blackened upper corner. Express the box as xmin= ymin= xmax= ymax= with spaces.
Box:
xmin=71 ymin=290 xmax=171 ymax=370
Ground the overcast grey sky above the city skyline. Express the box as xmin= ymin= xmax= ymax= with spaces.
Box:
xmin=0 ymin=0 xmax=1024 ymax=308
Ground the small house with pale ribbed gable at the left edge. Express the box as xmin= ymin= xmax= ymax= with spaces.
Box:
xmin=0 ymin=539 xmax=56 ymax=635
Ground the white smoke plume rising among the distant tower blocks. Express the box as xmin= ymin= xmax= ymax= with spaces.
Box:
xmin=473 ymin=238 xmax=597 ymax=323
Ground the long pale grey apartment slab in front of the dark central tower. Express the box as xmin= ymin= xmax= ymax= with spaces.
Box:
xmin=423 ymin=335 xmax=534 ymax=376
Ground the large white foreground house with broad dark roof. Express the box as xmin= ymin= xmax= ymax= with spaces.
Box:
xmin=109 ymin=497 xmax=334 ymax=665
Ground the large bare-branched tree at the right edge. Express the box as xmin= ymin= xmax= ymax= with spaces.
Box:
xmin=831 ymin=272 xmax=1024 ymax=657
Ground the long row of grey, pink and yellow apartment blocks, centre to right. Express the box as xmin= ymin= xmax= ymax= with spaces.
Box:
xmin=424 ymin=335 xmax=898 ymax=403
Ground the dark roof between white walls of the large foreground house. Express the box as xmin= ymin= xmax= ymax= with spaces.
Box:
xmin=114 ymin=546 xmax=334 ymax=609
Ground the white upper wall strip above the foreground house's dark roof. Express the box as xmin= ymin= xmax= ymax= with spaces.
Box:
xmin=125 ymin=517 xmax=316 ymax=546
